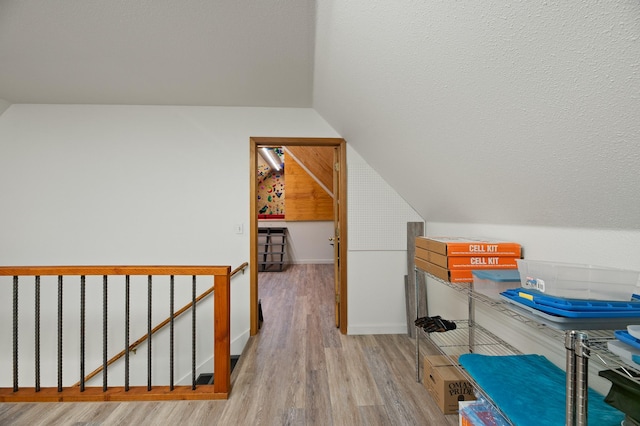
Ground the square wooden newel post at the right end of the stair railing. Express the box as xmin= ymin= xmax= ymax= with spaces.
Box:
xmin=213 ymin=267 xmax=231 ymax=393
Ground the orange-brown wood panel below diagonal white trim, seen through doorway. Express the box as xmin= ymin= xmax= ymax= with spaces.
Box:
xmin=284 ymin=155 xmax=333 ymax=221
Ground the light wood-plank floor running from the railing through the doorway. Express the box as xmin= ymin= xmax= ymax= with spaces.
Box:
xmin=0 ymin=265 xmax=458 ymax=426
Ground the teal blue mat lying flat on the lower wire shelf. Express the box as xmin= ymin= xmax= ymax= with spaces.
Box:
xmin=459 ymin=354 xmax=624 ymax=426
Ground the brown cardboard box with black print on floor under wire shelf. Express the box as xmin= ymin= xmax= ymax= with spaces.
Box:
xmin=422 ymin=355 xmax=476 ymax=414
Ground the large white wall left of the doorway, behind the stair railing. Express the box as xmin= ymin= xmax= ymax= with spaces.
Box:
xmin=0 ymin=105 xmax=337 ymax=383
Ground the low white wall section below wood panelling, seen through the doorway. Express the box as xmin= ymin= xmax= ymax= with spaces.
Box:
xmin=258 ymin=220 xmax=333 ymax=264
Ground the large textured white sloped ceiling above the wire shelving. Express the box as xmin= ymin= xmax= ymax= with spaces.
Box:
xmin=314 ymin=0 xmax=640 ymax=229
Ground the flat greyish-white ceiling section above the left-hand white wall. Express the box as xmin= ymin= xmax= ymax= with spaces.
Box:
xmin=0 ymin=0 xmax=315 ymax=107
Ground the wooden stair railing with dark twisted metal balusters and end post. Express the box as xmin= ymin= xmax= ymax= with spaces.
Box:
xmin=0 ymin=266 xmax=244 ymax=402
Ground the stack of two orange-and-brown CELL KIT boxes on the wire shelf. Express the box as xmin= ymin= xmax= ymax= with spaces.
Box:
xmin=415 ymin=237 xmax=522 ymax=282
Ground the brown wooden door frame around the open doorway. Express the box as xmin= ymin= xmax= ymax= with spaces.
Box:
xmin=249 ymin=137 xmax=347 ymax=336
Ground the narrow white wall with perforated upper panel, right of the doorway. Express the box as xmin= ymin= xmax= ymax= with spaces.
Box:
xmin=347 ymin=147 xmax=422 ymax=334
